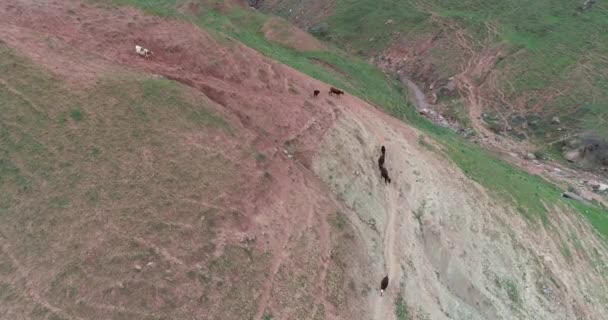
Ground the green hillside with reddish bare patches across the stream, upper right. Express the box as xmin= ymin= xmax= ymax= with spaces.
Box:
xmin=267 ymin=0 xmax=608 ymax=145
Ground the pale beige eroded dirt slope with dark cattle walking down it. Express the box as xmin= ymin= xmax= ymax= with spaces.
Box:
xmin=314 ymin=99 xmax=607 ymax=319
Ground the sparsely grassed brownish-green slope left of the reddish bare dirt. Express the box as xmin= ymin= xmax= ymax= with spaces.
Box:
xmin=0 ymin=42 xmax=280 ymax=319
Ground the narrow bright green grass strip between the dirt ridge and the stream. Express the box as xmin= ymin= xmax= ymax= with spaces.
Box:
xmin=98 ymin=0 xmax=608 ymax=237
